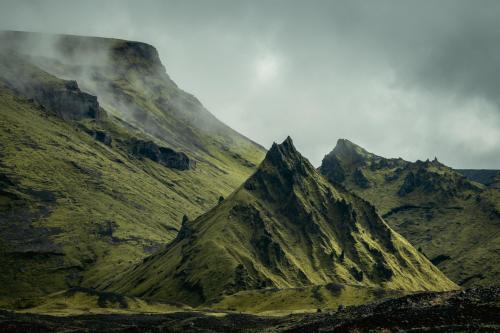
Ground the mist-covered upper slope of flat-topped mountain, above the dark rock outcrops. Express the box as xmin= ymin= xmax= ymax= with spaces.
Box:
xmin=0 ymin=31 xmax=264 ymax=174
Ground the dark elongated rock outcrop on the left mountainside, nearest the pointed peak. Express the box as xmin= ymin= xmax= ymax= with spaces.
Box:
xmin=127 ymin=139 xmax=195 ymax=170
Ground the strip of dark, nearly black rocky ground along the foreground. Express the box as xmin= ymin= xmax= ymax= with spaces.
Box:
xmin=0 ymin=287 xmax=500 ymax=332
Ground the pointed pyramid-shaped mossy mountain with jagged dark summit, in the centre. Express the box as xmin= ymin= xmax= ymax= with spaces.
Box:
xmin=106 ymin=138 xmax=456 ymax=308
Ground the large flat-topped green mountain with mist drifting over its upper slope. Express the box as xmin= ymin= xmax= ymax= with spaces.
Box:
xmin=0 ymin=32 xmax=265 ymax=308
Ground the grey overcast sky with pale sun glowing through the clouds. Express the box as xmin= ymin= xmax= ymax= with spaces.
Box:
xmin=0 ymin=0 xmax=500 ymax=168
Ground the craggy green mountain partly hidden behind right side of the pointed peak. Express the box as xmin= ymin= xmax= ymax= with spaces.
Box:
xmin=319 ymin=139 xmax=500 ymax=286
